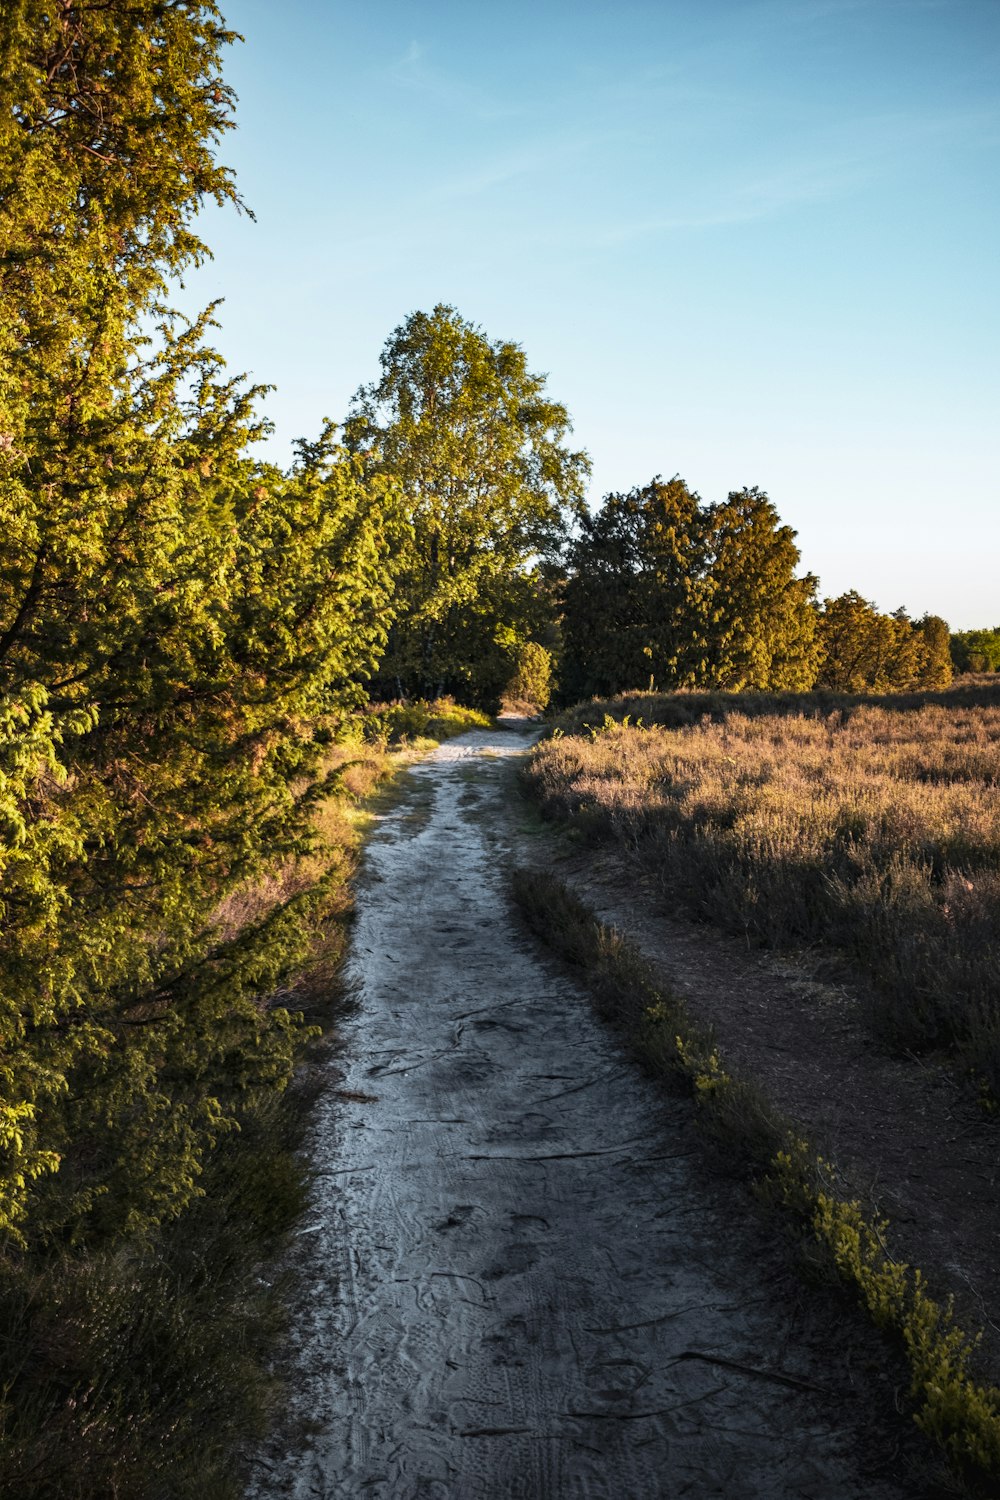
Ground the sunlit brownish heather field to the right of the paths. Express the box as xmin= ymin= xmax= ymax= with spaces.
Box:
xmin=528 ymin=680 xmax=1000 ymax=1104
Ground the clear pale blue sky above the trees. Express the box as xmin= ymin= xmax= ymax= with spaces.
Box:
xmin=189 ymin=0 xmax=1000 ymax=629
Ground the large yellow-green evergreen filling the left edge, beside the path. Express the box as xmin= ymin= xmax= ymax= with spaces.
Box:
xmin=0 ymin=0 xmax=388 ymax=1238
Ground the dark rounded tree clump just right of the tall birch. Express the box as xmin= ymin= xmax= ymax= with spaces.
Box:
xmin=561 ymin=477 xmax=820 ymax=701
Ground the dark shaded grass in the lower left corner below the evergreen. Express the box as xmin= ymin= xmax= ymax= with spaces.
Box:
xmin=0 ymin=1095 xmax=306 ymax=1500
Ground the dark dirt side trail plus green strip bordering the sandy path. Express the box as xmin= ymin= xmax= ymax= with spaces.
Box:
xmin=516 ymin=750 xmax=1000 ymax=1496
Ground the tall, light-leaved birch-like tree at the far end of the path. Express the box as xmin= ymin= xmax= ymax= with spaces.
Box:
xmin=346 ymin=306 xmax=588 ymax=707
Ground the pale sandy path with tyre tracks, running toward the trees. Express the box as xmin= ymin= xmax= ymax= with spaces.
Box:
xmin=250 ymin=731 xmax=928 ymax=1500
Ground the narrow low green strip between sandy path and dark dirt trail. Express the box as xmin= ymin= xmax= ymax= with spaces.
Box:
xmin=514 ymin=870 xmax=1000 ymax=1496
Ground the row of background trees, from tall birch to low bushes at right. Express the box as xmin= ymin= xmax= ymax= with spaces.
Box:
xmin=346 ymin=315 xmax=952 ymax=707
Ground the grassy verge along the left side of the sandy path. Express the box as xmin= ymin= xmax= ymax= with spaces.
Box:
xmin=0 ymin=702 xmax=486 ymax=1500
